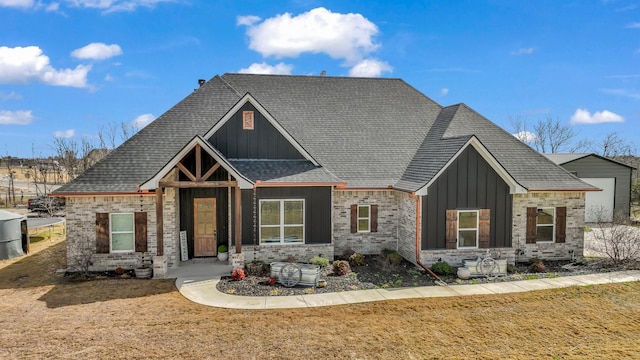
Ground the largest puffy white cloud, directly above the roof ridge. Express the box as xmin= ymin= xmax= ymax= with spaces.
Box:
xmin=243 ymin=7 xmax=380 ymax=64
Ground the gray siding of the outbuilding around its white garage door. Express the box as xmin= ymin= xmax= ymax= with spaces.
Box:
xmin=561 ymin=155 xmax=632 ymax=215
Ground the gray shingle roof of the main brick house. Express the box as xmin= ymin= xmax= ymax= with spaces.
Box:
xmin=57 ymin=74 xmax=588 ymax=193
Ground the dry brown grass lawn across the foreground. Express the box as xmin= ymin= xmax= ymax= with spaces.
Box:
xmin=0 ymin=239 xmax=640 ymax=359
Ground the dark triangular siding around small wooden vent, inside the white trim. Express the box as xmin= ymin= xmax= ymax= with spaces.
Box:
xmin=208 ymin=103 xmax=304 ymax=160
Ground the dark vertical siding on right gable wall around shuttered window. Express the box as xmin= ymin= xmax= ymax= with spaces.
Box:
xmin=421 ymin=146 xmax=513 ymax=250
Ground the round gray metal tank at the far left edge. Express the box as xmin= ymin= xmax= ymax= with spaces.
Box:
xmin=0 ymin=210 xmax=29 ymax=260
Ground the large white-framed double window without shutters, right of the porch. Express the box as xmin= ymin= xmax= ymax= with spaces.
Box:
xmin=260 ymin=200 xmax=304 ymax=244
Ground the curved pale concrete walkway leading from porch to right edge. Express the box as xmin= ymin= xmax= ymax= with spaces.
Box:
xmin=167 ymin=263 xmax=640 ymax=309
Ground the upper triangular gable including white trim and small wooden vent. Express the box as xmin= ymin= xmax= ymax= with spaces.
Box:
xmin=204 ymin=93 xmax=318 ymax=166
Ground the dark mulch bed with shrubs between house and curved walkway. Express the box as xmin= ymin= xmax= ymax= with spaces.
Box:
xmin=217 ymin=255 xmax=640 ymax=296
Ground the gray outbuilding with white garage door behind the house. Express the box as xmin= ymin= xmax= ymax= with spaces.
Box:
xmin=545 ymin=154 xmax=635 ymax=222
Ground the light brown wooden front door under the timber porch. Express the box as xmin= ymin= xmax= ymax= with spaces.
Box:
xmin=193 ymin=198 xmax=218 ymax=257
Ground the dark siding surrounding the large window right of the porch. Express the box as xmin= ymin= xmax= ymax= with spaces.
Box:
xmin=242 ymin=186 xmax=331 ymax=246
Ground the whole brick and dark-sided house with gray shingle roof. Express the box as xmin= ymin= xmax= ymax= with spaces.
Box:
xmin=52 ymin=74 xmax=597 ymax=276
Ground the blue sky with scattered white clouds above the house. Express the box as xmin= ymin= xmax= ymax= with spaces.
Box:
xmin=0 ymin=0 xmax=640 ymax=157
